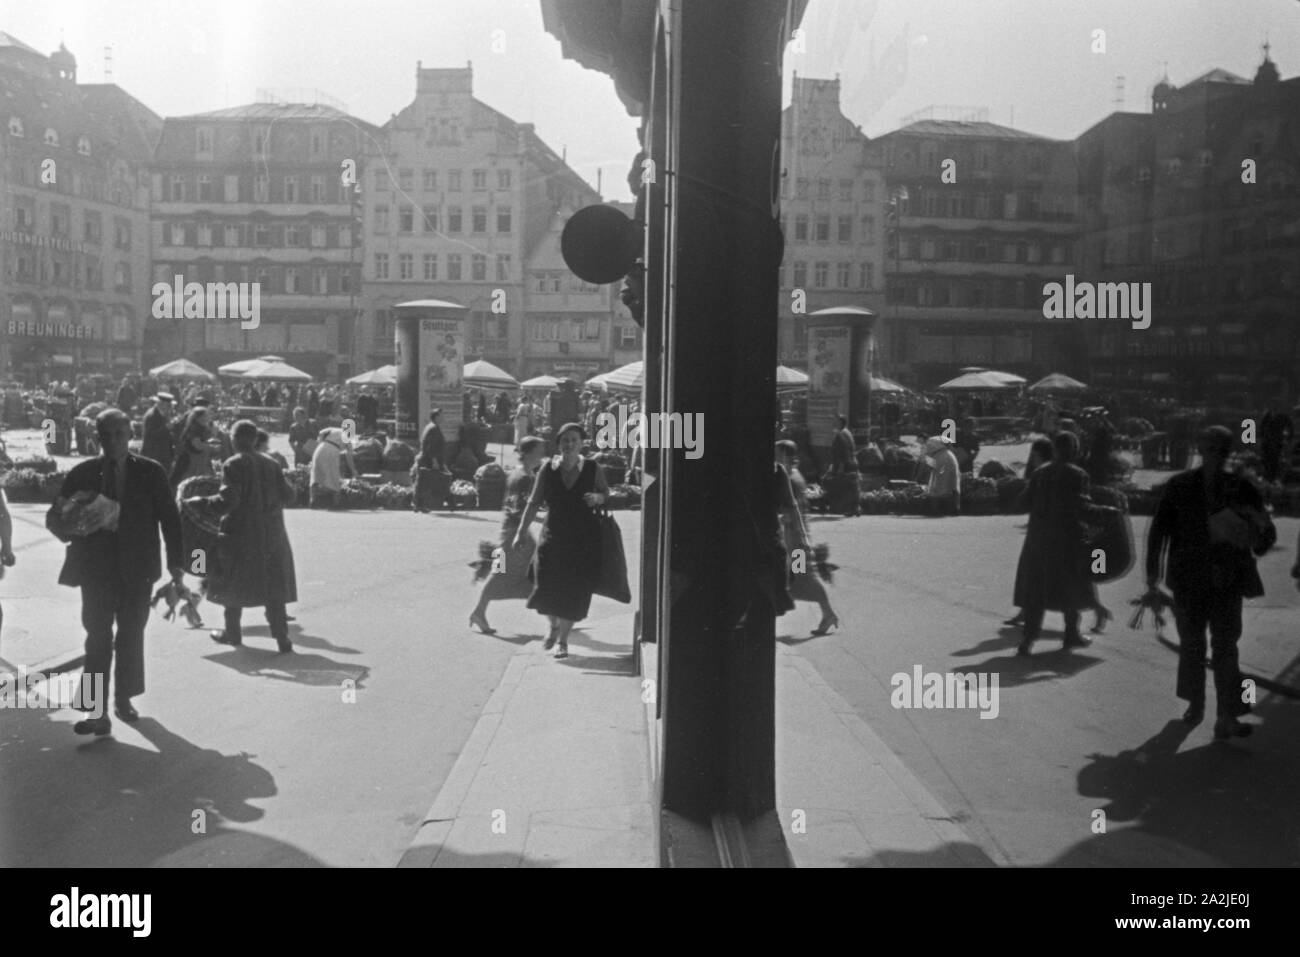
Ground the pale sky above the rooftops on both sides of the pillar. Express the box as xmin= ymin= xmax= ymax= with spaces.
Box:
xmin=0 ymin=0 xmax=1300 ymax=200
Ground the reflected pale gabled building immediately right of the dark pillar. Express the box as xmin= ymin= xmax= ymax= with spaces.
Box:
xmin=777 ymin=75 xmax=888 ymax=367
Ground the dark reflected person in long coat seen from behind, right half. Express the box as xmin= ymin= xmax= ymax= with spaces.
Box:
xmin=1015 ymin=432 xmax=1118 ymax=655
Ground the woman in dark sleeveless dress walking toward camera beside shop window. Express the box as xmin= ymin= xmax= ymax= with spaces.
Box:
xmin=514 ymin=423 xmax=610 ymax=658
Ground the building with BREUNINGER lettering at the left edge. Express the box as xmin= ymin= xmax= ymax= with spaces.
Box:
xmin=0 ymin=34 xmax=163 ymax=381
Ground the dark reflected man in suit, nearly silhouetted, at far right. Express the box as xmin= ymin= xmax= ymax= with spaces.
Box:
xmin=1147 ymin=425 xmax=1278 ymax=740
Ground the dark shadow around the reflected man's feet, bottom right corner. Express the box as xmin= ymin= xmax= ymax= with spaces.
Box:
xmin=1053 ymin=712 xmax=1300 ymax=867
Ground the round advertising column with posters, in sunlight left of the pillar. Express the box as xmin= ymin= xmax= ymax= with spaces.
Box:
xmin=394 ymin=299 xmax=465 ymax=445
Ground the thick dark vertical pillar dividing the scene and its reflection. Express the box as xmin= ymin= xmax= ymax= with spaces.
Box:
xmin=659 ymin=0 xmax=787 ymax=853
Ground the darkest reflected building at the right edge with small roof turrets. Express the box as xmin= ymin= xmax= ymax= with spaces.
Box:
xmin=1078 ymin=49 xmax=1300 ymax=407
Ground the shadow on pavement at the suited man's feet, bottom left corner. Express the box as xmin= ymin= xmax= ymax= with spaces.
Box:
xmin=0 ymin=709 xmax=324 ymax=867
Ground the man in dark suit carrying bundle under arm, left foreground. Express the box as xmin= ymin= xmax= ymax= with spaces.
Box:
xmin=46 ymin=408 xmax=185 ymax=735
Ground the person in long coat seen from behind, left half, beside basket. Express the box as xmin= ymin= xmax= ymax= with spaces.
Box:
xmin=185 ymin=420 xmax=298 ymax=654
